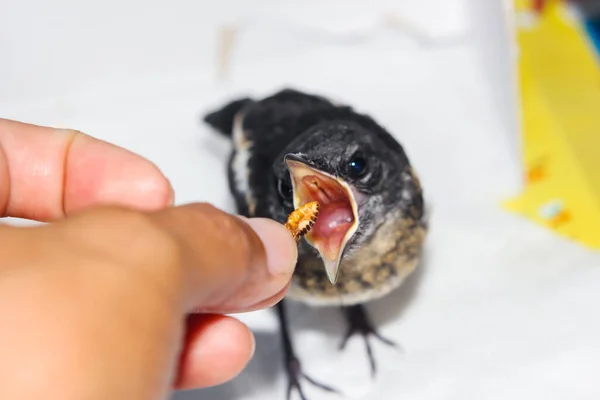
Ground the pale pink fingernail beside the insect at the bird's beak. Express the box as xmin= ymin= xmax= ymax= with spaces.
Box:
xmin=246 ymin=218 xmax=298 ymax=275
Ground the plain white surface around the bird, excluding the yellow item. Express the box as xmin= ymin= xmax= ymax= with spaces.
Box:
xmin=0 ymin=0 xmax=600 ymax=400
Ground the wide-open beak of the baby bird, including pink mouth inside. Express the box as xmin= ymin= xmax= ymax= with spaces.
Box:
xmin=285 ymin=154 xmax=359 ymax=284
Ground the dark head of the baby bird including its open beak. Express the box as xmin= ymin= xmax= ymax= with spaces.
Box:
xmin=271 ymin=122 xmax=422 ymax=284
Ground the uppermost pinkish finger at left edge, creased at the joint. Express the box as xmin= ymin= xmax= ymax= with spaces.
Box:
xmin=0 ymin=118 xmax=173 ymax=222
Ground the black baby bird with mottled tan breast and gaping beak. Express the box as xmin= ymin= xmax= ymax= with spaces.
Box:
xmin=204 ymin=89 xmax=428 ymax=400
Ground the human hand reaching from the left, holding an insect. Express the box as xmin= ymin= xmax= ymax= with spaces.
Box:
xmin=0 ymin=119 xmax=297 ymax=400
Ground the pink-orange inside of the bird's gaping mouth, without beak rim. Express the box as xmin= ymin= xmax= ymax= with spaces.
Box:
xmin=295 ymin=171 xmax=356 ymax=261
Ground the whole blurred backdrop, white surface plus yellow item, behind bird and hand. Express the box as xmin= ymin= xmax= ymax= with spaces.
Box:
xmin=0 ymin=0 xmax=600 ymax=400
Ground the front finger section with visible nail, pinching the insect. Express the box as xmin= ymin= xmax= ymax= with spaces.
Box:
xmin=151 ymin=204 xmax=298 ymax=314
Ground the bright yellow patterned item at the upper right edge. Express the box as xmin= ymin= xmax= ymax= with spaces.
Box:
xmin=504 ymin=0 xmax=600 ymax=250
